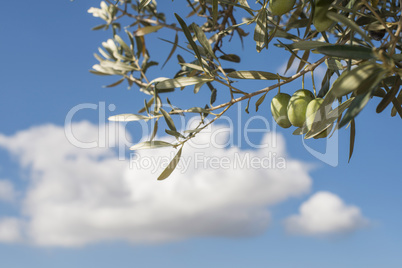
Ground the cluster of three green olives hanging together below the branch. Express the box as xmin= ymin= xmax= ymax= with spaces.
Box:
xmin=271 ymin=89 xmax=332 ymax=138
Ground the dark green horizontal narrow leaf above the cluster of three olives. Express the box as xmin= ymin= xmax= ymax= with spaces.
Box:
xmin=317 ymin=45 xmax=375 ymax=60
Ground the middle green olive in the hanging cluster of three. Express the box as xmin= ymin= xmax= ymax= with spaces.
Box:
xmin=287 ymin=89 xmax=314 ymax=127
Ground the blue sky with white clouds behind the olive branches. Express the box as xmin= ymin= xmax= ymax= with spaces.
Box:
xmin=0 ymin=0 xmax=402 ymax=268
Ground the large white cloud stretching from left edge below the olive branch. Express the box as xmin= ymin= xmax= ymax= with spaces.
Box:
xmin=0 ymin=122 xmax=311 ymax=246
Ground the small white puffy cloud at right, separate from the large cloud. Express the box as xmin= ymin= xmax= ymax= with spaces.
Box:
xmin=285 ymin=192 xmax=368 ymax=236
